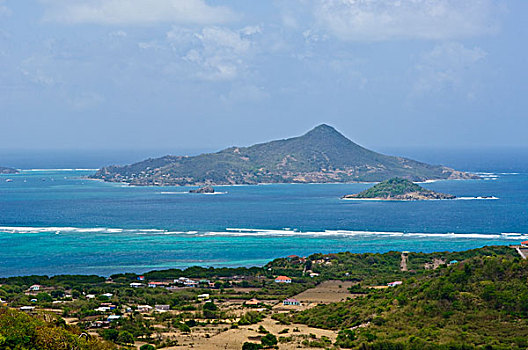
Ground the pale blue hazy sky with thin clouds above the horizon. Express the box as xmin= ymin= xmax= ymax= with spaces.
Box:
xmin=0 ymin=0 xmax=528 ymax=153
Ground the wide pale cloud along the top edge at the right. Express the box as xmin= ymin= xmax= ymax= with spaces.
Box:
xmin=314 ymin=0 xmax=499 ymax=41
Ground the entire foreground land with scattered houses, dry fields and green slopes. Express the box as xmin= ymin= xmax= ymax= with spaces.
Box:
xmin=0 ymin=247 xmax=528 ymax=350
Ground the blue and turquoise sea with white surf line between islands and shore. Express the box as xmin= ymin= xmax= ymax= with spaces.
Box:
xmin=0 ymin=170 xmax=528 ymax=276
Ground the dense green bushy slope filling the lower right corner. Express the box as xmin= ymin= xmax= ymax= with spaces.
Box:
xmin=293 ymin=256 xmax=528 ymax=349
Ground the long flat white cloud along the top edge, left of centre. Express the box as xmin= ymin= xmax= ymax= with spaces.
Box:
xmin=41 ymin=0 xmax=235 ymax=25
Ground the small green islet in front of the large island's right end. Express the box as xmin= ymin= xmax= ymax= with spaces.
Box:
xmin=341 ymin=177 xmax=456 ymax=201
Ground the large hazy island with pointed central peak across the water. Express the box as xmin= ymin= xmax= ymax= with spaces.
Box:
xmin=92 ymin=124 xmax=477 ymax=186
